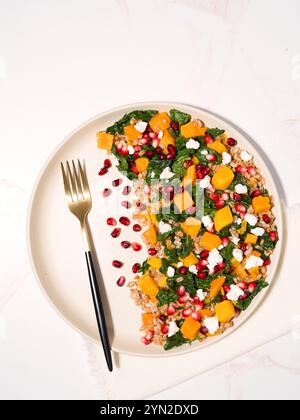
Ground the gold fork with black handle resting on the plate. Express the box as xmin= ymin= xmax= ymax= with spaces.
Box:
xmin=61 ymin=159 xmax=113 ymax=372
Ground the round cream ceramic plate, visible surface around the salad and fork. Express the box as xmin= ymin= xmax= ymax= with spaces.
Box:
xmin=27 ymin=102 xmax=282 ymax=357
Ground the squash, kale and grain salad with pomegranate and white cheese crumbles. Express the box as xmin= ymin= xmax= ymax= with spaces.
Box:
xmin=97 ymin=109 xmax=278 ymax=350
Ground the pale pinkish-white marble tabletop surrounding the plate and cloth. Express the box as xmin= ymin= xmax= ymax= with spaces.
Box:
xmin=0 ymin=0 xmax=300 ymax=399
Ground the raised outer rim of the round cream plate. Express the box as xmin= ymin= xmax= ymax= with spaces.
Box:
xmin=26 ymin=100 xmax=286 ymax=358
